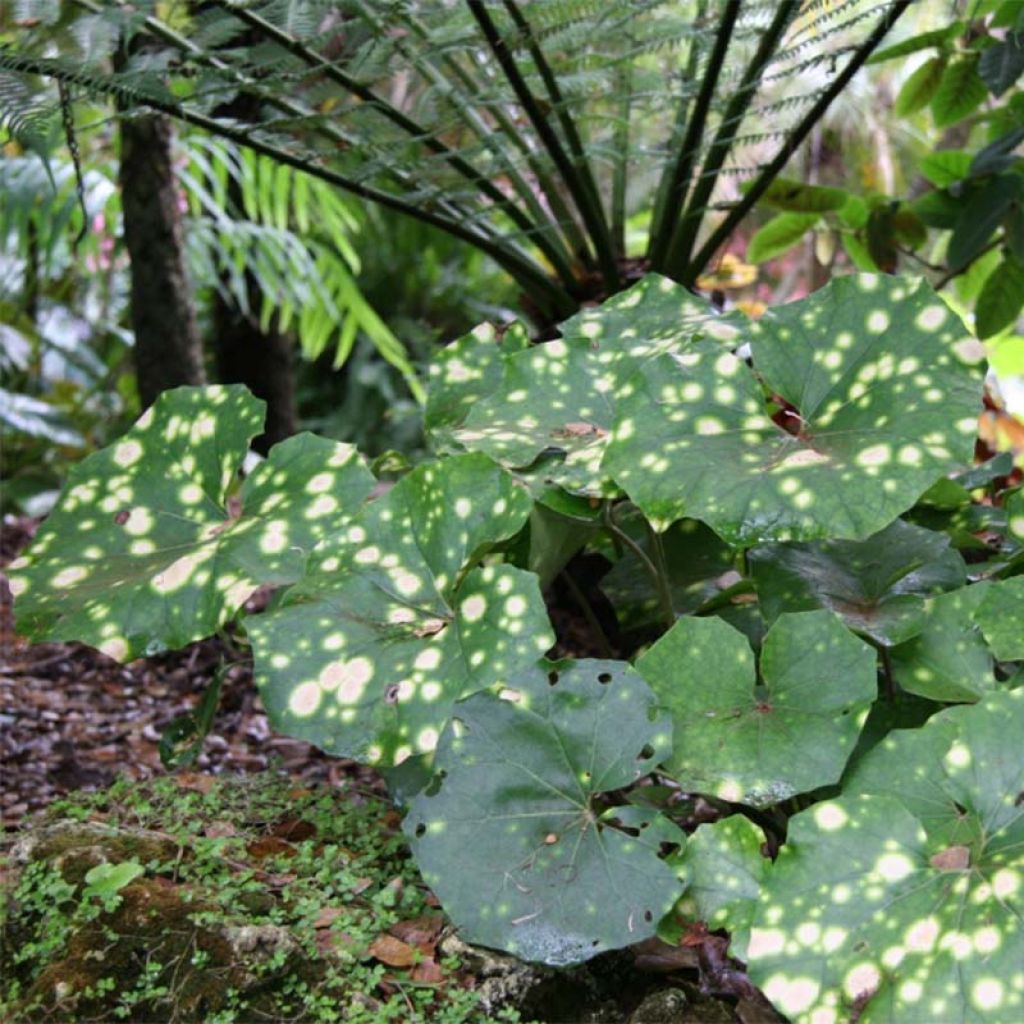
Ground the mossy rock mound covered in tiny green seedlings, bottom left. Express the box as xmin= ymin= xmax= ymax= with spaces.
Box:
xmin=0 ymin=773 xmax=517 ymax=1024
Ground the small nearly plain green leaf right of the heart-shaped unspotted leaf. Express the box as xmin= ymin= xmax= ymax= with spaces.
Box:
xmin=892 ymin=584 xmax=995 ymax=701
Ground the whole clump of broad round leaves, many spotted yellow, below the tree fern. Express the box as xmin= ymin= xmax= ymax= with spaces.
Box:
xmin=10 ymin=274 xmax=1024 ymax=1024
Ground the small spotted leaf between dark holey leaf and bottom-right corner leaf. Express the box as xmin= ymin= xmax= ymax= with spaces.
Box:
xmin=663 ymin=814 xmax=768 ymax=959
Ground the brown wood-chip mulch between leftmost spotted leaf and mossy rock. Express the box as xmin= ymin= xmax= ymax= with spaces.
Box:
xmin=0 ymin=517 xmax=380 ymax=831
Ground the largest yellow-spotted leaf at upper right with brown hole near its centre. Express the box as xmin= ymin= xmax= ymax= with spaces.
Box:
xmin=604 ymin=274 xmax=980 ymax=545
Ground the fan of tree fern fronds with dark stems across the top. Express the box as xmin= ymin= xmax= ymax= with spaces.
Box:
xmin=0 ymin=0 xmax=909 ymax=315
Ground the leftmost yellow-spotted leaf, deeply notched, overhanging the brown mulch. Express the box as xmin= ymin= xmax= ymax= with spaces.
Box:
xmin=10 ymin=385 xmax=374 ymax=660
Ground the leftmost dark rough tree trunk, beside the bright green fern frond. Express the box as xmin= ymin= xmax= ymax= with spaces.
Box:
xmin=121 ymin=115 xmax=205 ymax=408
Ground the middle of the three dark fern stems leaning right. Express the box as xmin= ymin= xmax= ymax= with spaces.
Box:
xmin=665 ymin=0 xmax=800 ymax=281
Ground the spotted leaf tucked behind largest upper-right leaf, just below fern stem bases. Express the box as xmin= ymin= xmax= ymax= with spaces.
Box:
xmin=453 ymin=274 xmax=731 ymax=496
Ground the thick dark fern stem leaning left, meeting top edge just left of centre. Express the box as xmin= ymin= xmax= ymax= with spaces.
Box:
xmin=466 ymin=0 xmax=618 ymax=292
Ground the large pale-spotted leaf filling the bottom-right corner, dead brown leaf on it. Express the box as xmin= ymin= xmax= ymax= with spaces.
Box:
xmin=748 ymin=690 xmax=1024 ymax=1024
